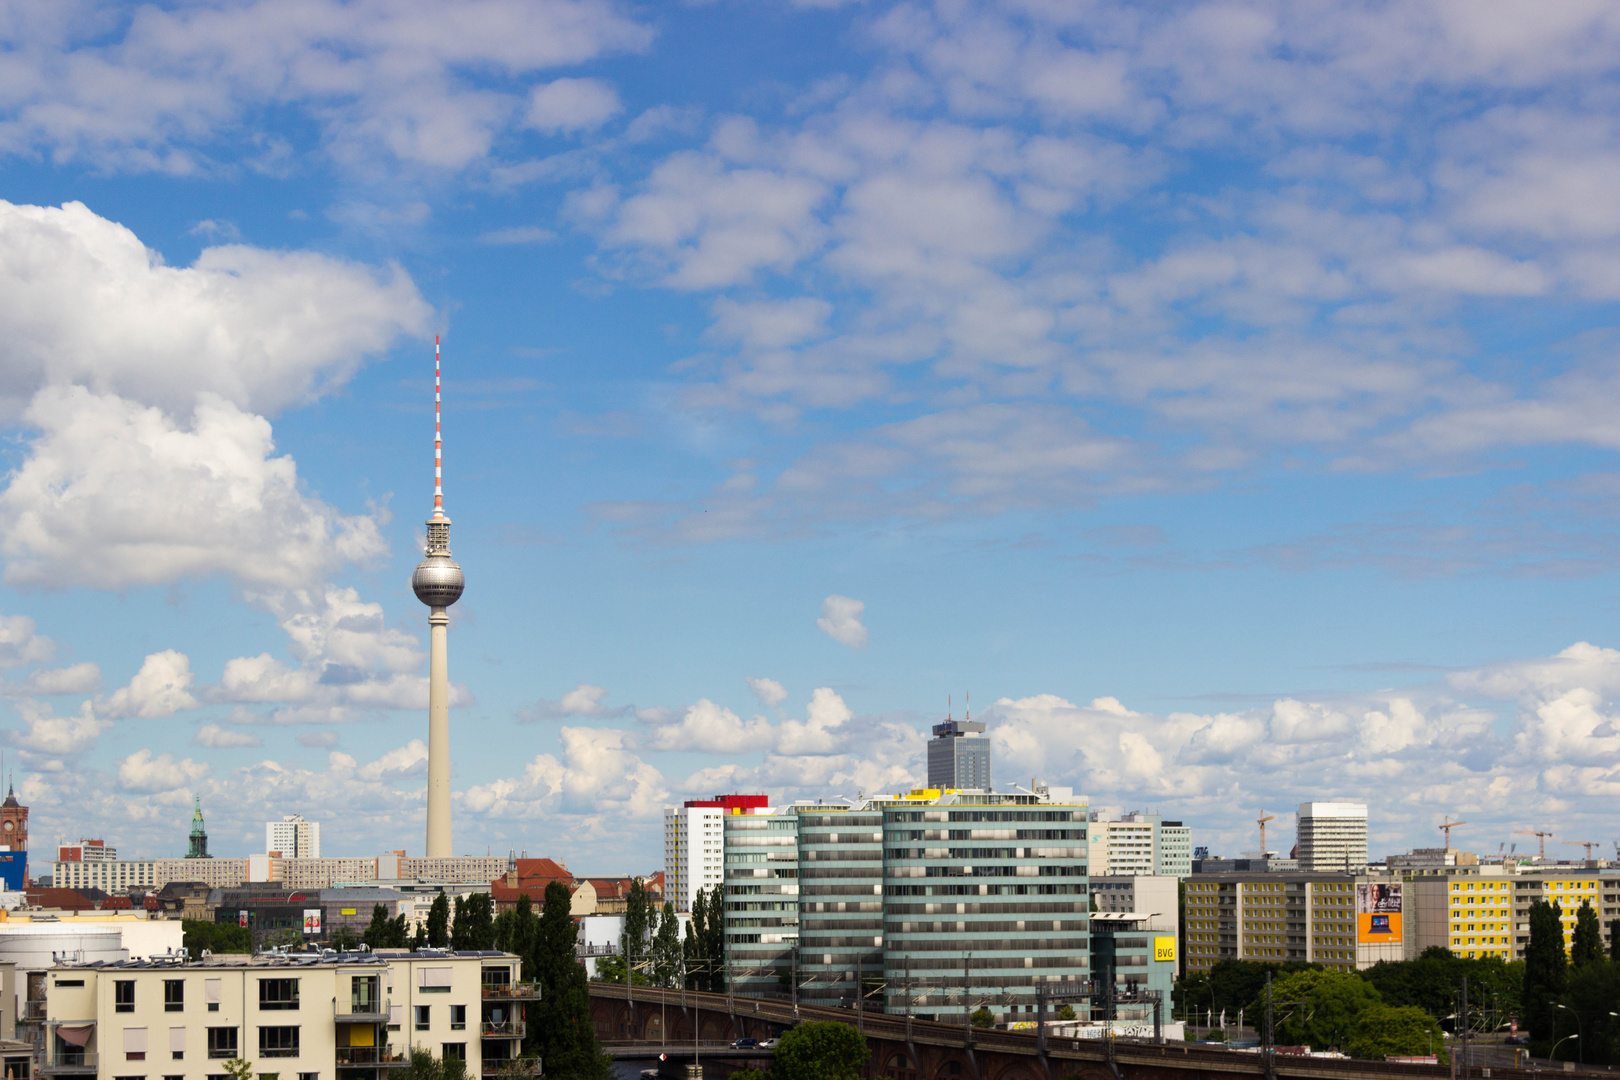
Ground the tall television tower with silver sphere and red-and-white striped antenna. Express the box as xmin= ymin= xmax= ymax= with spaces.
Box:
xmin=410 ymin=337 xmax=465 ymax=858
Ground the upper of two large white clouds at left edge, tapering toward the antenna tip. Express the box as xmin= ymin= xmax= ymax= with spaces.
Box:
xmin=0 ymin=202 xmax=428 ymax=415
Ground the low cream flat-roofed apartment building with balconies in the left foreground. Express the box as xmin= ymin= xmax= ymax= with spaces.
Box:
xmin=41 ymin=952 xmax=535 ymax=1080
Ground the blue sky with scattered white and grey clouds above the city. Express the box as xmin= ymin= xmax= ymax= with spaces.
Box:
xmin=0 ymin=0 xmax=1620 ymax=873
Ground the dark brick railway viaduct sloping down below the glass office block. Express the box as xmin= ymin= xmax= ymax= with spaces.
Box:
xmin=591 ymin=983 xmax=1496 ymax=1080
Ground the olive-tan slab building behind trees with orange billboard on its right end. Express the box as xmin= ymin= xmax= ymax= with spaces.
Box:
xmin=1186 ymin=873 xmax=1367 ymax=973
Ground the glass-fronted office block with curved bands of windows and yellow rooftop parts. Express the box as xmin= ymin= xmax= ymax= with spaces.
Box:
xmin=724 ymin=787 xmax=1090 ymax=1017
